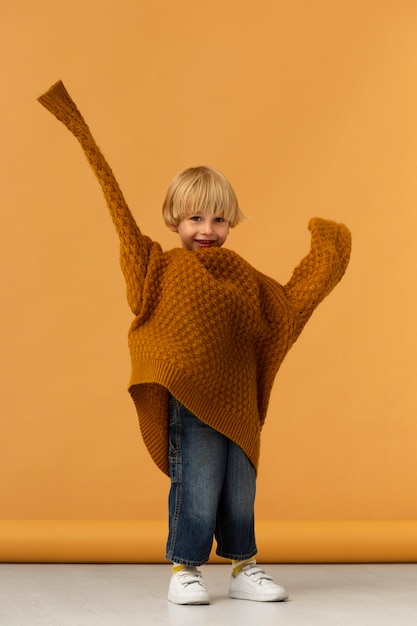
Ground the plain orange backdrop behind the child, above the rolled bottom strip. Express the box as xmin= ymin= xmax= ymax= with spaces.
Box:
xmin=0 ymin=0 xmax=417 ymax=548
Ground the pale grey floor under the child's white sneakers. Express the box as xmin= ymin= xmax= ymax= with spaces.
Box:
xmin=0 ymin=564 xmax=417 ymax=626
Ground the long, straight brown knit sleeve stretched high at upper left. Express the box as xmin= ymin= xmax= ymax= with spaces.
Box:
xmin=38 ymin=81 xmax=153 ymax=314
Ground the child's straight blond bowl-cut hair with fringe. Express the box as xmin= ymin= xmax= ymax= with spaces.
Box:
xmin=162 ymin=165 xmax=245 ymax=228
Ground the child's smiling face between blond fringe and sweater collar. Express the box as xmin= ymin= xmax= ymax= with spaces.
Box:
xmin=169 ymin=211 xmax=229 ymax=250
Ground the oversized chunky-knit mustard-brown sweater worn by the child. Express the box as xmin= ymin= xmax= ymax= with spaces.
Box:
xmin=39 ymin=81 xmax=351 ymax=474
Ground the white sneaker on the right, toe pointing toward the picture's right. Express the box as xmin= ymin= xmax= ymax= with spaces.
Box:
xmin=229 ymin=563 xmax=288 ymax=602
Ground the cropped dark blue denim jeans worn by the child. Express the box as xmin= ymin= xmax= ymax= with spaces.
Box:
xmin=166 ymin=397 xmax=257 ymax=566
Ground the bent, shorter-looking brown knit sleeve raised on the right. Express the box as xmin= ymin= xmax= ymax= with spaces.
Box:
xmin=284 ymin=218 xmax=351 ymax=335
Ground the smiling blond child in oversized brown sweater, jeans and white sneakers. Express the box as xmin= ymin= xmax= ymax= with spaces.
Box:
xmin=39 ymin=82 xmax=350 ymax=604
